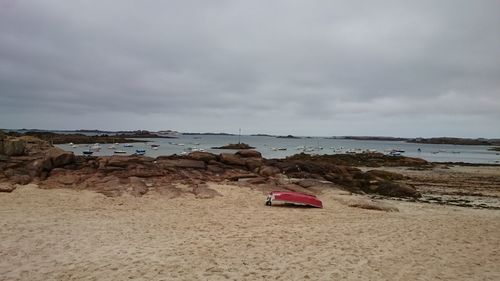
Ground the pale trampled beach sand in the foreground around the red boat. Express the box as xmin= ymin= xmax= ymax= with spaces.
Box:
xmin=0 ymin=185 xmax=500 ymax=280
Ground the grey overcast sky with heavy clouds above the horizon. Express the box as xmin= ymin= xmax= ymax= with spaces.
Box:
xmin=0 ymin=0 xmax=500 ymax=137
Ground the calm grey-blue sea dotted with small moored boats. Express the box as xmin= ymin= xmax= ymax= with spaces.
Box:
xmin=57 ymin=135 xmax=500 ymax=164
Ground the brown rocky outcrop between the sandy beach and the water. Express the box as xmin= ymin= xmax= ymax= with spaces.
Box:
xmin=0 ymin=135 xmax=500 ymax=207
